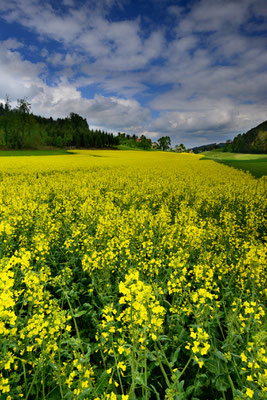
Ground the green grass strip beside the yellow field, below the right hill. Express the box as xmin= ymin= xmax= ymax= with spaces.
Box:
xmin=201 ymin=150 xmax=267 ymax=178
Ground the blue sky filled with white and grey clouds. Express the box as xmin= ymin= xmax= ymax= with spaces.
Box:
xmin=0 ymin=0 xmax=267 ymax=147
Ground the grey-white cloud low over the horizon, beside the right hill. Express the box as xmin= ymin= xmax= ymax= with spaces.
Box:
xmin=149 ymin=101 xmax=266 ymax=146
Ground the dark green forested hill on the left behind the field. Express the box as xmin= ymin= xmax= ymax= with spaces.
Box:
xmin=0 ymin=99 xmax=118 ymax=149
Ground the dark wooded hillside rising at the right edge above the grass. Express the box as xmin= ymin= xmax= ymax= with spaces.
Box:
xmin=225 ymin=121 xmax=267 ymax=154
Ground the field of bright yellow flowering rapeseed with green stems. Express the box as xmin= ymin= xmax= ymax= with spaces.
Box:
xmin=0 ymin=151 xmax=267 ymax=400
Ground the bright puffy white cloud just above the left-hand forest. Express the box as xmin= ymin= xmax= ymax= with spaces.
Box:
xmin=0 ymin=41 xmax=150 ymax=131
